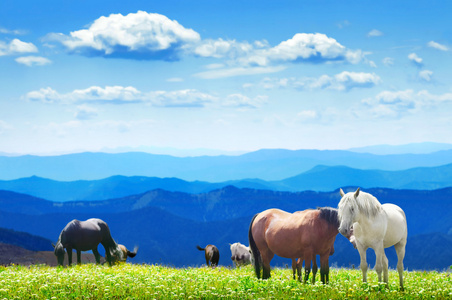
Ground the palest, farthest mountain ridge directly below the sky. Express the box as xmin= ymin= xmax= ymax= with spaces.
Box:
xmin=0 ymin=149 xmax=452 ymax=182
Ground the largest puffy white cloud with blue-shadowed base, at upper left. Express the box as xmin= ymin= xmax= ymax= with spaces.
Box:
xmin=48 ymin=11 xmax=200 ymax=60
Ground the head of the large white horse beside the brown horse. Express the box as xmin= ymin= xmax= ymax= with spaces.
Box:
xmin=338 ymin=188 xmax=359 ymax=239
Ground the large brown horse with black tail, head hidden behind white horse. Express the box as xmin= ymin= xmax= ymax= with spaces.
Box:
xmin=248 ymin=207 xmax=339 ymax=283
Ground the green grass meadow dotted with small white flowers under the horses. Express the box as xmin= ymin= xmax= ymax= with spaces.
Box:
xmin=0 ymin=264 xmax=452 ymax=299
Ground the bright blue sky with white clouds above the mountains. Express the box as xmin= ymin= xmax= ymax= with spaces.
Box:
xmin=0 ymin=0 xmax=452 ymax=154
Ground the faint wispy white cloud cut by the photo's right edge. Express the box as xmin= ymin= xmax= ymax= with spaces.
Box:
xmin=362 ymin=90 xmax=452 ymax=118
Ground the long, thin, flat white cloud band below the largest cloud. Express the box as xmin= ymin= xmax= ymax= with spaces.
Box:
xmin=25 ymin=86 xmax=267 ymax=108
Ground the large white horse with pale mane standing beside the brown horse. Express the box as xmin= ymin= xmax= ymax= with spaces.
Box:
xmin=338 ymin=188 xmax=408 ymax=290
